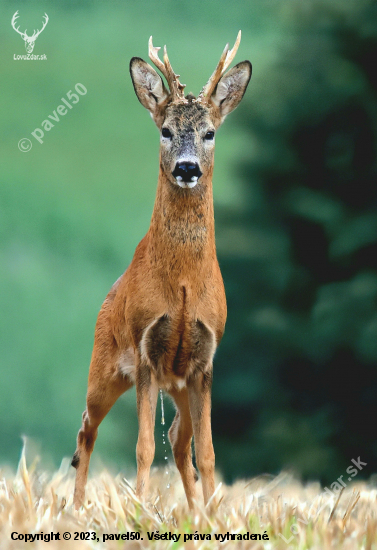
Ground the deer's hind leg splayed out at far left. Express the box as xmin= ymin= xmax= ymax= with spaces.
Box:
xmin=72 ymin=354 xmax=133 ymax=509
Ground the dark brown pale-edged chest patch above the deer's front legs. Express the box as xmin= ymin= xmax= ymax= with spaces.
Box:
xmin=140 ymin=315 xmax=216 ymax=389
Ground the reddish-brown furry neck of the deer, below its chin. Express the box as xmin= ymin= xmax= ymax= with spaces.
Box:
xmin=148 ymin=167 xmax=216 ymax=277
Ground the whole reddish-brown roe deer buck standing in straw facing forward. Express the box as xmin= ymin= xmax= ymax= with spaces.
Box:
xmin=72 ymin=32 xmax=251 ymax=508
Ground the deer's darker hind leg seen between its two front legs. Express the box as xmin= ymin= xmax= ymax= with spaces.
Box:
xmin=169 ymin=388 xmax=198 ymax=509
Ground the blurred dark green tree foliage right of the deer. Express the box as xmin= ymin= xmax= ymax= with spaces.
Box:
xmin=213 ymin=0 xmax=377 ymax=482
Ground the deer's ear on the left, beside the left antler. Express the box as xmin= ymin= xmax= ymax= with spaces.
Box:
xmin=130 ymin=57 xmax=170 ymax=126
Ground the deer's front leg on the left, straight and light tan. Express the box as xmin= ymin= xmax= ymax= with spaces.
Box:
xmin=136 ymin=361 xmax=158 ymax=499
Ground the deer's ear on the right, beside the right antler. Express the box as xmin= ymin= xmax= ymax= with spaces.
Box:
xmin=211 ymin=61 xmax=251 ymax=118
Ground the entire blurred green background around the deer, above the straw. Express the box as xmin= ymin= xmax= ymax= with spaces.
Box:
xmin=0 ymin=0 xmax=377 ymax=483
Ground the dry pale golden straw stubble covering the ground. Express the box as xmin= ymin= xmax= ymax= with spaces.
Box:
xmin=0 ymin=446 xmax=377 ymax=550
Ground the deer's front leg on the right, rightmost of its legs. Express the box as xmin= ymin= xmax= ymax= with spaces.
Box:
xmin=188 ymin=372 xmax=215 ymax=504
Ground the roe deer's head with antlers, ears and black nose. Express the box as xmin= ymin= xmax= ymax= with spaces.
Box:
xmin=130 ymin=31 xmax=251 ymax=189
